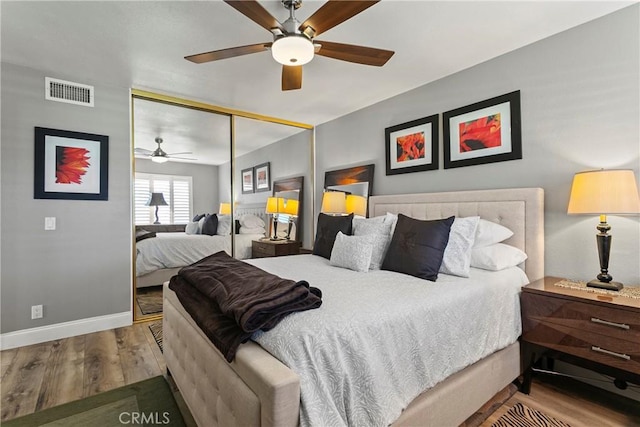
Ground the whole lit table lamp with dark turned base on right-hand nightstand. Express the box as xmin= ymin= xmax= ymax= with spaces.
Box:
xmin=567 ymin=170 xmax=640 ymax=291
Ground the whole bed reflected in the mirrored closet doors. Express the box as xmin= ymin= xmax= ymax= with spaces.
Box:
xmin=136 ymin=204 xmax=268 ymax=288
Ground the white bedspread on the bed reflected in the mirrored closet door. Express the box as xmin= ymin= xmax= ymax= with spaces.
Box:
xmin=136 ymin=233 xmax=264 ymax=276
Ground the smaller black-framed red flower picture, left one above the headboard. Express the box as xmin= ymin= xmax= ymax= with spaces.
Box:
xmin=384 ymin=114 xmax=438 ymax=175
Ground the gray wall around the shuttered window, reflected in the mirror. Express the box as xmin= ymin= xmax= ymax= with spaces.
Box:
xmin=135 ymin=159 xmax=220 ymax=215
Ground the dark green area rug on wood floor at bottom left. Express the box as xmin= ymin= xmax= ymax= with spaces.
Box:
xmin=2 ymin=376 xmax=185 ymax=427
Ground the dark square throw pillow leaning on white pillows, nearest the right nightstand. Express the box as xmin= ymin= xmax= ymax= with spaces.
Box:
xmin=382 ymin=214 xmax=455 ymax=282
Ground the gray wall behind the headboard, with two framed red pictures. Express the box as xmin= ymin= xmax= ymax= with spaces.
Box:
xmin=316 ymin=4 xmax=640 ymax=284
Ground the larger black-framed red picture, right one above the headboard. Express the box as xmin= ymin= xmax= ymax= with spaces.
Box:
xmin=442 ymin=91 xmax=522 ymax=169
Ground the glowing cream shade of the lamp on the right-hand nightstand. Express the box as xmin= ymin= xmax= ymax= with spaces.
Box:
xmin=567 ymin=169 xmax=640 ymax=215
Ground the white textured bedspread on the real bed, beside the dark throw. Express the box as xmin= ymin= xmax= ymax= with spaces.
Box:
xmin=248 ymin=255 xmax=528 ymax=426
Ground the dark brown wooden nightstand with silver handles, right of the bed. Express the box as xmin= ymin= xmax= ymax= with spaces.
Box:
xmin=520 ymin=277 xmax=640 ymax=394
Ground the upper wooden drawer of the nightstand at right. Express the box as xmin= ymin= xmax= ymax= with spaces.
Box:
xmin=521 ymin=292 xmax=640 ymax=347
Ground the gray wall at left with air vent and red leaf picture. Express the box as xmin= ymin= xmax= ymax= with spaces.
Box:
xmin=0 ymin=63 xmax=132 ymax=333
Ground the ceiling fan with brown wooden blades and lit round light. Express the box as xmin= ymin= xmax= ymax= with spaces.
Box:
xmin=185 ymin=0 xmax=394 ymax=90
